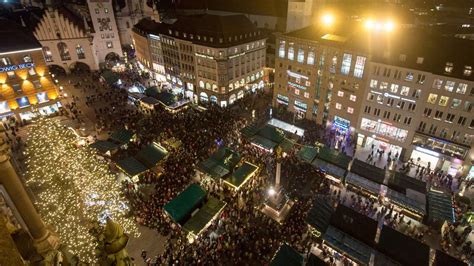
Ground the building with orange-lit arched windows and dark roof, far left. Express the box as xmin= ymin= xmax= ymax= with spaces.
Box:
xmin=0 ymin=20 xmax=60 ymax=120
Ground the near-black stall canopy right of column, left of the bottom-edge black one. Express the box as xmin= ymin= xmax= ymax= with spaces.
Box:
xmin=330 ymin=204 xmax=377 ymax=247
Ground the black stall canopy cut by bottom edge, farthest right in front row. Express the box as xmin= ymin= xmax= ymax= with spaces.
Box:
xmin=378 ymin=226 xmax=430 ymax=266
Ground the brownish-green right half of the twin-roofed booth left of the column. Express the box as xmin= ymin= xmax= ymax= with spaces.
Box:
xmin=183 ymin=197 xmax=226 ymax=235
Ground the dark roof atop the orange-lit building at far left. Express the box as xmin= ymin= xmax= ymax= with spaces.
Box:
xmin=0 ymin=18 xmax=41 ymax=53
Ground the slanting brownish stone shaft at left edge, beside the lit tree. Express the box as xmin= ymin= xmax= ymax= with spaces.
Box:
xmin=0 ymin=138 xmax=59 ymax=255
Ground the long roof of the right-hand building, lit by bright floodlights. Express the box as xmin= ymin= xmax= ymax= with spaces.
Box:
xmin=285 ymin=22 xmax=474 ymax=81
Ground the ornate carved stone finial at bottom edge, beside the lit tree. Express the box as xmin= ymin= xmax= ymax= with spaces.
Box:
xmin=97 ymin=218 xmax=134 ymax=266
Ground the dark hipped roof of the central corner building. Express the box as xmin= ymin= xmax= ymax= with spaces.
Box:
xmin=134 ymin=14 xmax=265 ymax=47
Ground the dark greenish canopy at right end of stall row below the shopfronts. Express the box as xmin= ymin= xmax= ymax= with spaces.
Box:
xmin=428 ymin=190 xmax=454 ymax=224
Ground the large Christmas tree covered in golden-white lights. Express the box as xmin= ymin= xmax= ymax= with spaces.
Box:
xmin=26 ymin=118 xmax=138 ymax=263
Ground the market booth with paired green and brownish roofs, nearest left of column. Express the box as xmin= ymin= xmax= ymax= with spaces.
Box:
xmin=164 ymin=184 xmax=226 ymax=242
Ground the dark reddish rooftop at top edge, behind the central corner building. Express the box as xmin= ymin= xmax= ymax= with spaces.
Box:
xmin=177 ymin=0 xmax=289 ymax=17
